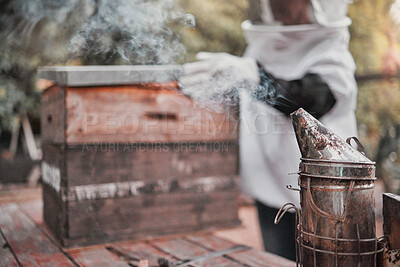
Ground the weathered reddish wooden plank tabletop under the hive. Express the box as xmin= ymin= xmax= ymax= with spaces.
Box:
xmin=0 ymin=188 xmax=295 ymax=267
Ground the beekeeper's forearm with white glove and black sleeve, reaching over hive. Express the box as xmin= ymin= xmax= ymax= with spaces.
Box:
xmin=180 ymin=52 xmax=336 ymax=118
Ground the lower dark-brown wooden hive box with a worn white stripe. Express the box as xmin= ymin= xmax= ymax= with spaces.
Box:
xmin=42 ymin=142 xmax=239 ymax=249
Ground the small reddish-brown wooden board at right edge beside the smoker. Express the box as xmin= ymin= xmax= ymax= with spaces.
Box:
xmin=383 ymin=193 xmax=400 ymax=250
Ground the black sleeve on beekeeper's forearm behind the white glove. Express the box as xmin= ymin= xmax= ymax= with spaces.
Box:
xmin=253 ymin=65 xmax=336 ymax=119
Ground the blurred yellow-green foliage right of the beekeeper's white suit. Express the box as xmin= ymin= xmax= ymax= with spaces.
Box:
xmin=349 ymin=0 xmax=400 ymax=161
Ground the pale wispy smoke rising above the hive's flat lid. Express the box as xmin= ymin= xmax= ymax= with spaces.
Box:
xmin=70 ymin=0 xmax=194 ymax=64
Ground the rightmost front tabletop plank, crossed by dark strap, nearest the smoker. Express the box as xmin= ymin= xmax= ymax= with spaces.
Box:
xmin=186 ymin=235 xmax=296 ymax=267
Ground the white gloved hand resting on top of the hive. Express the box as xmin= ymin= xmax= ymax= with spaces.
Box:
xmin=179 ymin=52 xmax=260 ymax=100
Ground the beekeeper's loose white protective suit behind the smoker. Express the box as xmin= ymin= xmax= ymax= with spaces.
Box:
xmin=240 ymin=0 xmax=357 ymax=208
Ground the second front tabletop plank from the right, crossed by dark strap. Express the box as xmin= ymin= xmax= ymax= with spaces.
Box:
xmin=151 ymin=238 xmax=243 ymax=267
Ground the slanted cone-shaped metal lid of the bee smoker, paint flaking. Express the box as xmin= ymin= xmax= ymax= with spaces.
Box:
xmin=290 ymin=108 xmax=372 ymax=162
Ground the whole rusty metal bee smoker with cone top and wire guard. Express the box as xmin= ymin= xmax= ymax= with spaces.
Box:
xmin=275 ymin=109 xmax=382 ymax=267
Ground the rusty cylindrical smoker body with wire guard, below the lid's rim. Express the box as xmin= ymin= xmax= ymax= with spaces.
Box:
xmin=300 ymin=176 xmax=377 ymax=266
